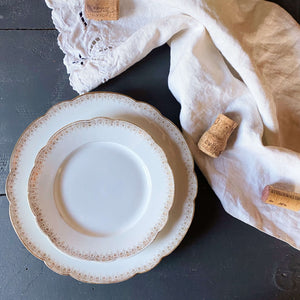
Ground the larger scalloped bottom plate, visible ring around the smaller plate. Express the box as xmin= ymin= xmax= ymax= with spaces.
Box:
xmin=6 ymin=93 xmax=197 ymax=283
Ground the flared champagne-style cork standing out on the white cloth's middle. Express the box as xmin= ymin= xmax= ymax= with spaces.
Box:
xmin=198 ymin=114 xmax=238 ymax=158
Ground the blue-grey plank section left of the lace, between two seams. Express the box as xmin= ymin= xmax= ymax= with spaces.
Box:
xmin=0 ymin=30 xmax=76 ymax=194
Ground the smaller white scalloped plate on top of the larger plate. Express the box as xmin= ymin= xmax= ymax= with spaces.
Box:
xmin=28 ymin=118 xmax=174 ymax=261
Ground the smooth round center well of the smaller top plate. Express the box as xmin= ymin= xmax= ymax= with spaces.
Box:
xmin=54 ymin=142 xmax=151 ymax=236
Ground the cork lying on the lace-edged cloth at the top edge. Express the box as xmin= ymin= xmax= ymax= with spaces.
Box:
xmin=85 ymin=0 xmax=119 ymax=21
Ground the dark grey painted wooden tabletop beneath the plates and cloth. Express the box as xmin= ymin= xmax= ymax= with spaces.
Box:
xmin=0 ymin=0 xmax=300 ymax=300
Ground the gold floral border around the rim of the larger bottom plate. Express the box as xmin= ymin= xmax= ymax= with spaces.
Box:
xmin=5 ymin=92 xmax=198 ymax=284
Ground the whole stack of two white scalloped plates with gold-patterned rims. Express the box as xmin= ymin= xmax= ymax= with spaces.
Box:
xmin=6 ymin=93 xmax=197 ymax=283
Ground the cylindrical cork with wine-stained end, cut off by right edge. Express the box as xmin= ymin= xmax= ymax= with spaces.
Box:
xmin=262 ymin=185 xmax=300 ymax=211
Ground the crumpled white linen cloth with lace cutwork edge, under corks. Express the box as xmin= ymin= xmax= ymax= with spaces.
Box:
xmin=46 ymin=0 xmax=300 ymax=249
